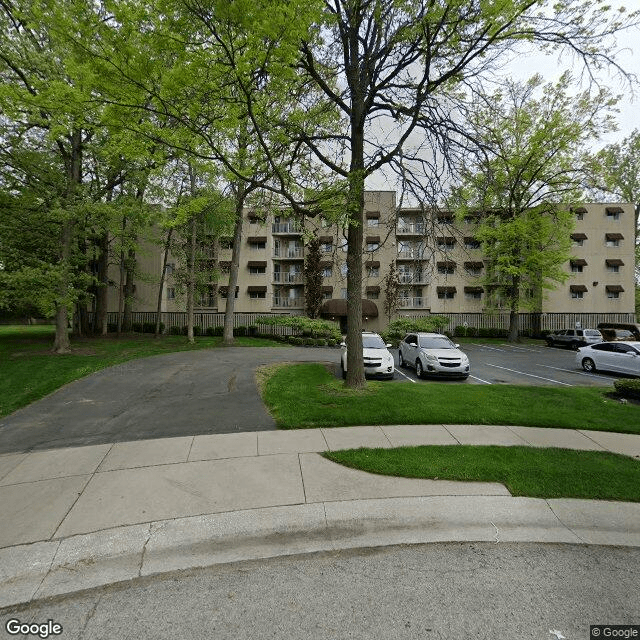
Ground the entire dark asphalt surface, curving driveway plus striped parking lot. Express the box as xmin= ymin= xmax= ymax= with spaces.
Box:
xmin=0 ymin=343 xmax=617 ymax=454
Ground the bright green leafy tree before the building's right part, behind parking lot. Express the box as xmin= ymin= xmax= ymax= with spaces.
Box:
xmin=456 ymin=74 xmax=614 ymax=341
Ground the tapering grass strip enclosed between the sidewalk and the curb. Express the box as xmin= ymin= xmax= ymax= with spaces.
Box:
xmin=323 ymin=445 xmax=640 ymax=502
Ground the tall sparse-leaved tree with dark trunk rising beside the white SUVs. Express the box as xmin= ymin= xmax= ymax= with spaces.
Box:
xmin=268 ymin=0 xmax=637 ymax=388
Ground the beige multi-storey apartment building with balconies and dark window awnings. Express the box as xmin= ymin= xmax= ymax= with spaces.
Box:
xmin=110 ymin=191 xmax=635 ymax=330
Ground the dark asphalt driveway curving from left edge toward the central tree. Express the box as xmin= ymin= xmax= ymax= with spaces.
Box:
xmin=0 ymin=347 xmax=339 ymax=454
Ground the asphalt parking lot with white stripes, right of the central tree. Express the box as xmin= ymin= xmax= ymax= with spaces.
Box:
xmin=391 ymin=342 xmax=621 ymax=387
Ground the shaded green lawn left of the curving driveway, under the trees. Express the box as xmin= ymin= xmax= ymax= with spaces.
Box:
xmin=0 ymin=325 xmax=284 ymax=416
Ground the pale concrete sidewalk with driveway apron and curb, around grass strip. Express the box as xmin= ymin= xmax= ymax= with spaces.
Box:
xmin=0 ymin=425 xmax=640 ymax=607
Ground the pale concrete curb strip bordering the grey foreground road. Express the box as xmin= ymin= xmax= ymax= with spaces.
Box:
xmin=0 ymin=496 xmax=640 ymax=608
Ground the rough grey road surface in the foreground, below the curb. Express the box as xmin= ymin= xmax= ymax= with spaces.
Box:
xmin=0 ymin=543 xmax=640 ymax=640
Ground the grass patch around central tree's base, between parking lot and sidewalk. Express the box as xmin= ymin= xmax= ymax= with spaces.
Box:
xmin=262 ymin=364 xmax=640 ymax=433
